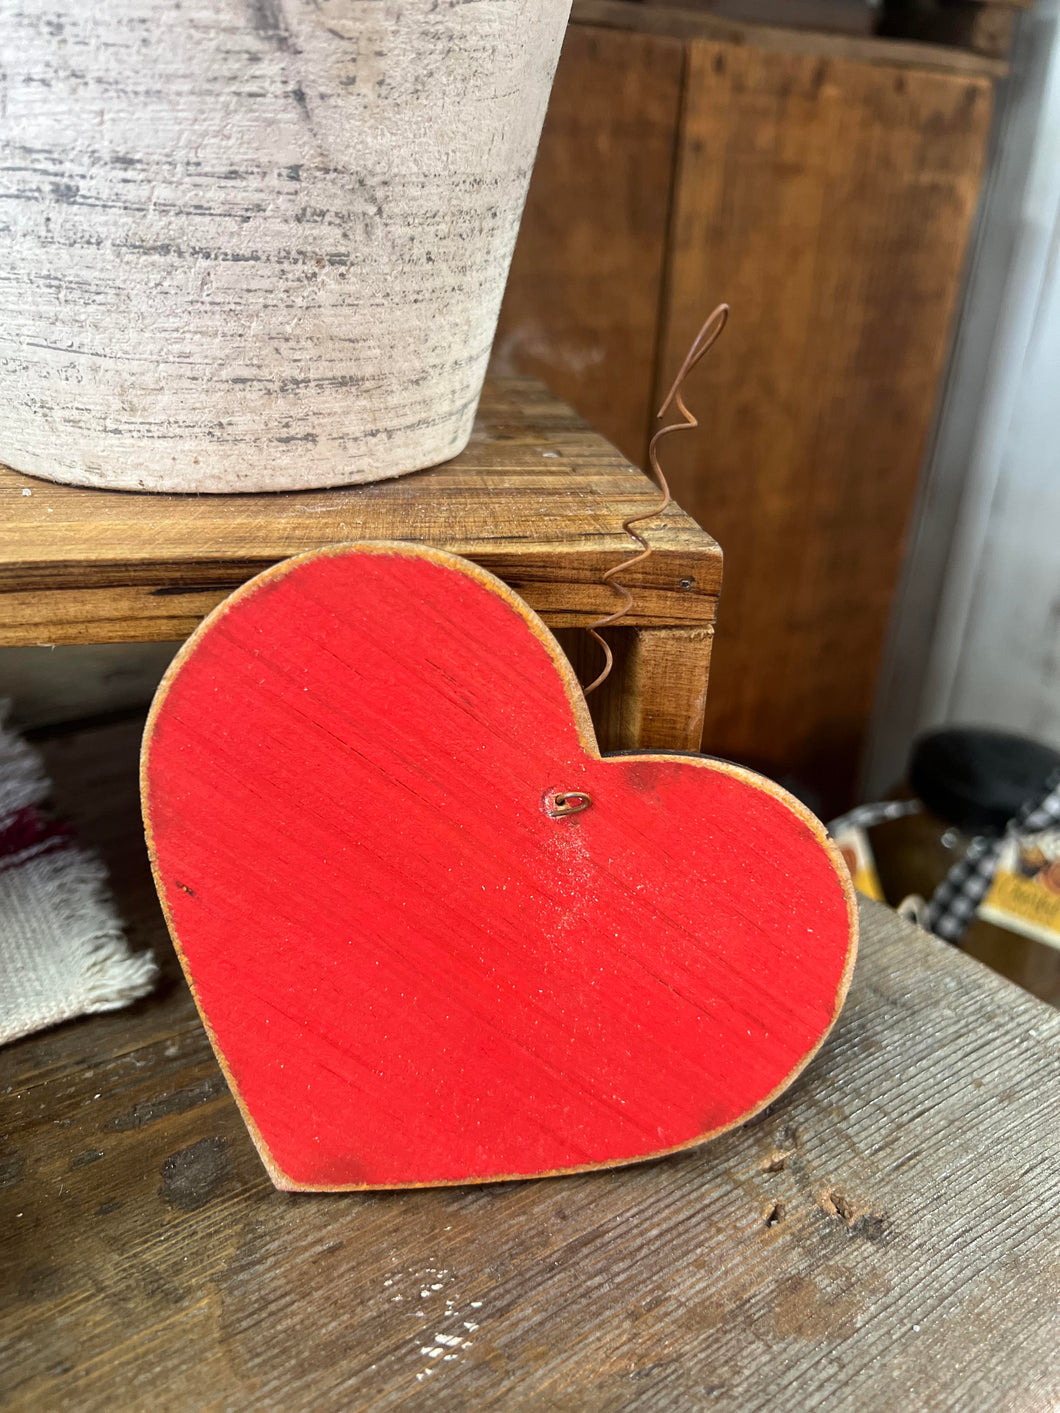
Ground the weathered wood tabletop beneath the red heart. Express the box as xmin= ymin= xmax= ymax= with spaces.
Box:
xmin=0 ymin=722 xmax=1060 ymax=1413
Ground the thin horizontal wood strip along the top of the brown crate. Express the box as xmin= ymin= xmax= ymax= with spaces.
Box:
xmin=571 ymin=0 xmax=1009 ymax=79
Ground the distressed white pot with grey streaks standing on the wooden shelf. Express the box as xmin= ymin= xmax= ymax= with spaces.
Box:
xmin=0 ymin=0 xmax=570 ymax=492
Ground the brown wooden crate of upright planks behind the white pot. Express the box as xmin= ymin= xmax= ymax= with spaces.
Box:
xmin=496 ymin=0 xmax=1003 ymax=810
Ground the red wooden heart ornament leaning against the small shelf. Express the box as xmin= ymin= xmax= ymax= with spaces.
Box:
xmin=143 ymin=544 xmax=856 ymax=1190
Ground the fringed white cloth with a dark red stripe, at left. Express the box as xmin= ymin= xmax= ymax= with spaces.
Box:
xmin=0 ymin=702 xmax=158 ymax=1044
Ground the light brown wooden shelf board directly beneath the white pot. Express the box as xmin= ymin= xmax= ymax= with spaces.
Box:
xmin=0 ymin=379 xmax=721 ymax=643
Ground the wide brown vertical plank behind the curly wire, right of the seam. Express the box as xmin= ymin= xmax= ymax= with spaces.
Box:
xmin=659 ymin=40 xmax=991 ymax=811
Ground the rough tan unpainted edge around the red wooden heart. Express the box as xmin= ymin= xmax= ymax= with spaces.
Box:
xmin=140 ymin=540 xmax=859 ymax=1193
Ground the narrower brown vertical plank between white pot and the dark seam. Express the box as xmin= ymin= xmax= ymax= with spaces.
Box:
xmin=493 ymin=25 xmax=684 ymax=466
